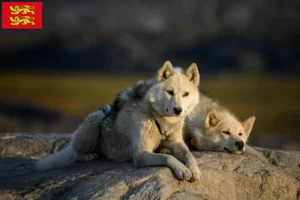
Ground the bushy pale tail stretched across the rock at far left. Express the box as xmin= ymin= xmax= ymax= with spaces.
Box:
xmin=36 ymin=143 xmax=78 ymax=170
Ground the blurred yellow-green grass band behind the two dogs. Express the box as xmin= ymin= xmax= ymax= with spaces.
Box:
xmin=0 ymin=73 xmax=300 ymax=133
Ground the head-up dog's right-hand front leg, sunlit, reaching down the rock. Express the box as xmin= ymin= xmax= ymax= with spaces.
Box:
xmin=163 ymin=140 xmax=201 ymax=180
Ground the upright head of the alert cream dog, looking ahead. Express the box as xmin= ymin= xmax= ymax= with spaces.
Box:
xmin=146 ymin=61 xmax=200 ymax=117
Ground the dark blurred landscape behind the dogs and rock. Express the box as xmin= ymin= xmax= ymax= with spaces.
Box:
xmin=0 ymin=0 xmax=300 ymax=150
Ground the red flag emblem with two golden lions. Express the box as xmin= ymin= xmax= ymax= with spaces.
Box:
xmin=2 ymin=2 xmax=42 ymax=29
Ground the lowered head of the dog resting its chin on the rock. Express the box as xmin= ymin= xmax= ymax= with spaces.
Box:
xmin=199 ymin=107 xmax=255 ymax=154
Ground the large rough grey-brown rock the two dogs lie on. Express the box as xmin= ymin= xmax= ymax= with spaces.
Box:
xmin=0 ymin=134 xmax=300 ymax=200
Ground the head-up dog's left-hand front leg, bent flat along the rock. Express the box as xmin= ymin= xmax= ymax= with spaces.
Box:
xmin=133 ymin=151 xmax=192 ymax=180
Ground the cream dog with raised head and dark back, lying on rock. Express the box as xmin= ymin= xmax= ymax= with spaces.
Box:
xmin=37 ymin=61 xmax=200 ymax=180
